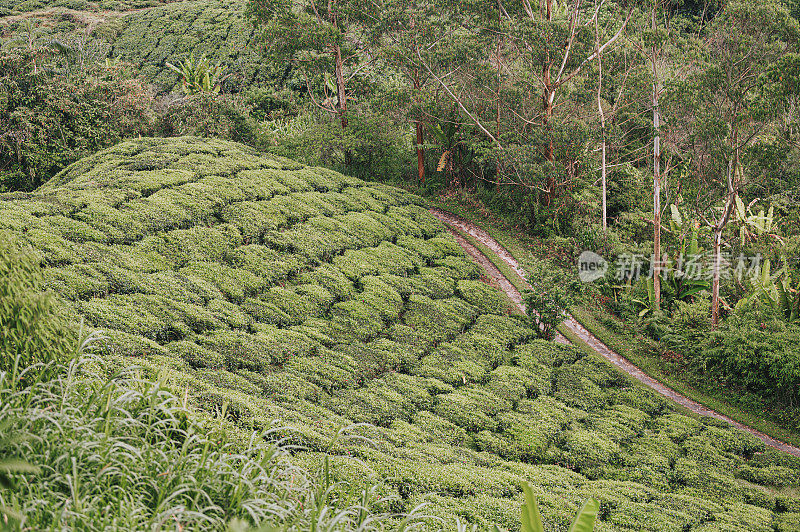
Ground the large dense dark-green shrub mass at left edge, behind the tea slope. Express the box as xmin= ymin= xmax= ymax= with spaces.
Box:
xmin=0 ymin=51 xmax=151 ymax=191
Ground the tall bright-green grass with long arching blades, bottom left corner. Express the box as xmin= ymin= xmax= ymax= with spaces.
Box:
xmin=0 ymin=342 xmax=432 ymax=530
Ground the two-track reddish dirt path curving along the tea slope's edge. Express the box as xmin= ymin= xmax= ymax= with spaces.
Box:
xmin=431 ymin=209 xmax=800 ymax=456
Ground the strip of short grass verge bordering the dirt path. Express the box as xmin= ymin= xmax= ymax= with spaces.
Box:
xmin=430 ymin=195 xmax=800 ymax=445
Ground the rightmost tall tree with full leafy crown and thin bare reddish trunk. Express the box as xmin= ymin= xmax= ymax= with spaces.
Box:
xmin=671 ymin=0 xmax=800 ymax=327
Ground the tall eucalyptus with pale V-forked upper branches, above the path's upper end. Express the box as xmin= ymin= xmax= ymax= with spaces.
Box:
xmin=422 ymin=0 xmax=630 ymax=205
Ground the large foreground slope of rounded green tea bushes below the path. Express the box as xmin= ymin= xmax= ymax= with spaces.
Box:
xmin=0 ymin=137 xmax=800 ymax=531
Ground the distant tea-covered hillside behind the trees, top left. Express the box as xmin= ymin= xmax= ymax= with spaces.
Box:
xmin=0 ymin=0 xmax=272 ymax=92
